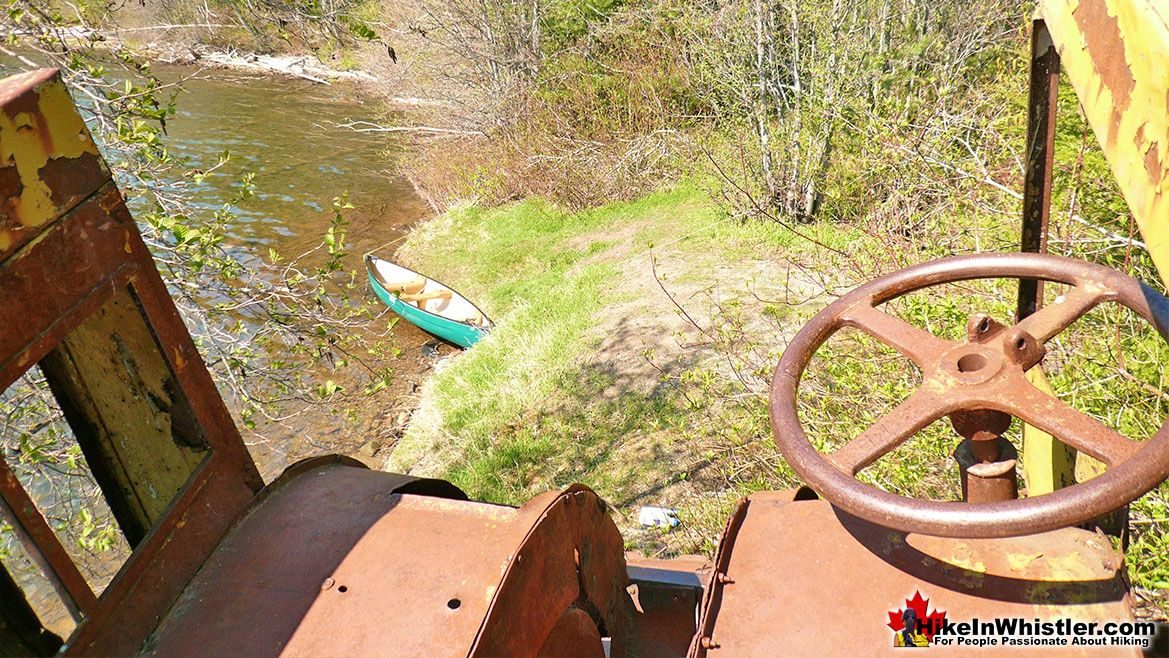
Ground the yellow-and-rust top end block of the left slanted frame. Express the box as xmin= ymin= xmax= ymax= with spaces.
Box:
xmin=0 ymin=69 xmax=110 ymax=261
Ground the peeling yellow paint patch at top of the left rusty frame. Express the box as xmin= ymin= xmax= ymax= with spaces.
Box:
xmin=0 ymin=73 xmax=98 ymax=241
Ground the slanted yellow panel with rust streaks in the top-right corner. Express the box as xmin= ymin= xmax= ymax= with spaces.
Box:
xmin=1038 ymin=0 xmax=1169 ymax=279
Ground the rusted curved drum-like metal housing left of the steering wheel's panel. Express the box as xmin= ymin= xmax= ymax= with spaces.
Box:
xmin=144 ymin=463 xmax=632 ymax=656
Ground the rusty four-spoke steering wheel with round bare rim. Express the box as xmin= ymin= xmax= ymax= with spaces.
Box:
xmin=770 ymin=254 xmax=1169 ymax=538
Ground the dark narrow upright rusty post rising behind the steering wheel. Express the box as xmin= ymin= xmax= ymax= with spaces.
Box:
xmin=1016 ymin=20 xmax=1059 ymax=320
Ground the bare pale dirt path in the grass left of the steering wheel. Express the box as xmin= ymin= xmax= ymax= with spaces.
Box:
xmin=568 ymin=236 xmax=823 ymax=528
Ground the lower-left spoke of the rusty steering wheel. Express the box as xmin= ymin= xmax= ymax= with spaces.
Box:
xmin=828 ymin=388 xmax=947 ymax=476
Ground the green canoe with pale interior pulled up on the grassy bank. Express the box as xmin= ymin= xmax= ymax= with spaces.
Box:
xmin=366 ymin=255 xmax=491 ymax=347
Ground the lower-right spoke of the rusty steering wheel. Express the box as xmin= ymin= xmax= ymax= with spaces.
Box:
xmin=1002 ymin=379 xmax=1141 ymax=466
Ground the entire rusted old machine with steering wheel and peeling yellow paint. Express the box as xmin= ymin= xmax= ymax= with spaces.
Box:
xmin=0 ymin=0 xmax=1169 ymax=657
